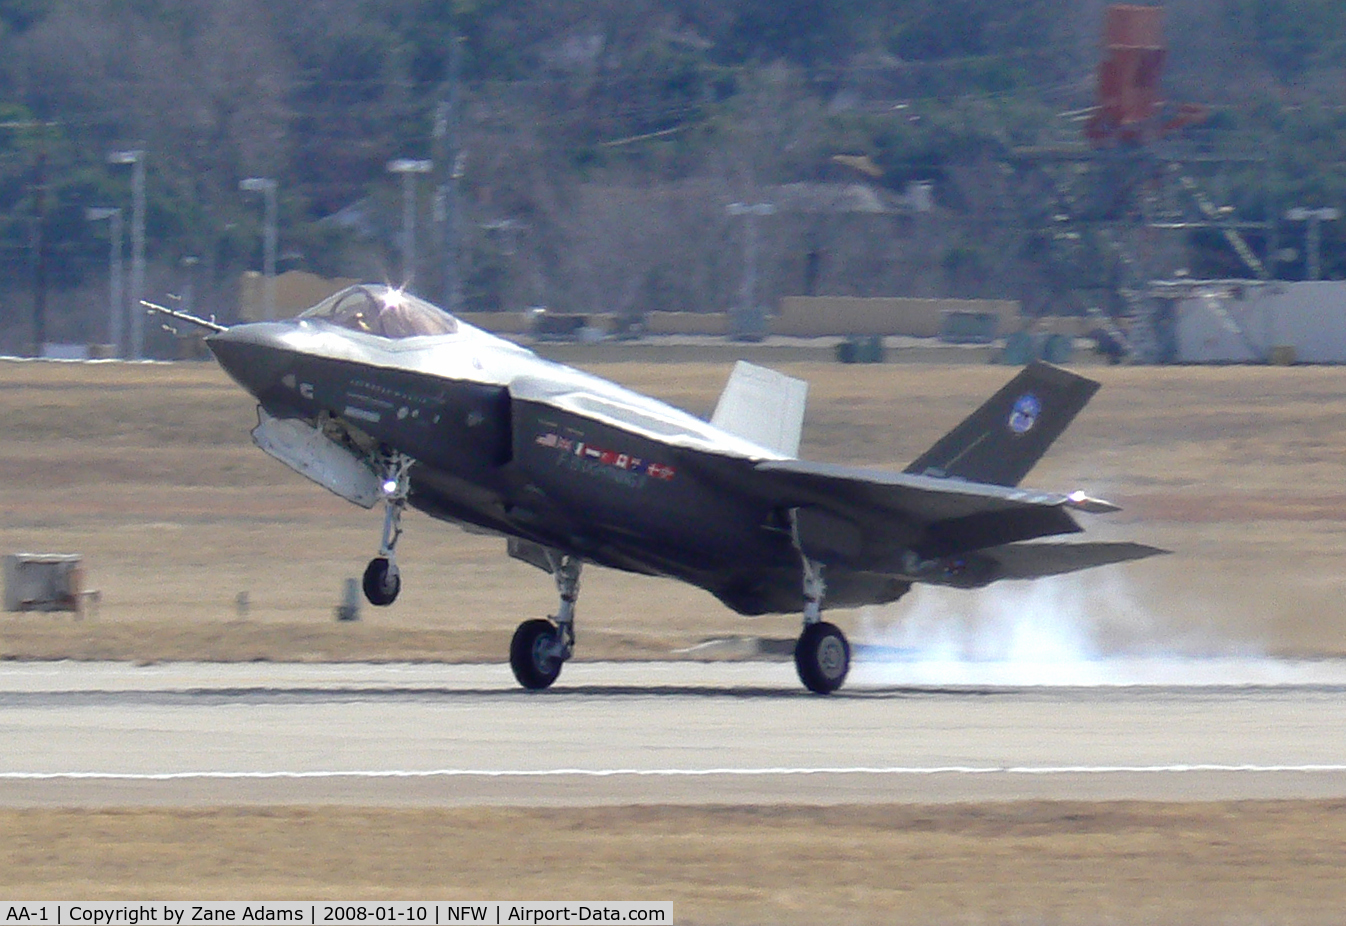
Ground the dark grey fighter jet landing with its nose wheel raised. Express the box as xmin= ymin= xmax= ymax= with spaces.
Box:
xmin=168 ymin=285 xmax=1160 ymax=693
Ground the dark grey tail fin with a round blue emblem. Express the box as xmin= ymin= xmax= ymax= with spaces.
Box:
xmin=906 ymin=361 xmax=1098 ymax=486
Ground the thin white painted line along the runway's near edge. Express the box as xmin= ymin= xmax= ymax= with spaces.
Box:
xmin=0 ymin=763 xmax=1346 ymax=781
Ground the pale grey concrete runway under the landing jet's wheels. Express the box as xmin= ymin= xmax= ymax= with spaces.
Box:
xmin=0 ymin=661 xmax=1346 ymax=806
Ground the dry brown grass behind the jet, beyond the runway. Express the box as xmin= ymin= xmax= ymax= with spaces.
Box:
xmin=0 ymin=362 xmax=1346 ymax=660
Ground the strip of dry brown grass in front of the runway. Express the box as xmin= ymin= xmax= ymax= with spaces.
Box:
xmin=0 ymin=802 xmax=1346 ymax=925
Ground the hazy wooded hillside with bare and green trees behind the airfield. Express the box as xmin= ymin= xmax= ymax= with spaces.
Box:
xmin=0 ymin=0 xmax=1346 ymax=346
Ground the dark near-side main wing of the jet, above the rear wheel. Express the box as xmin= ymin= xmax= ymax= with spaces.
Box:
xmin=755 ymin=460 xmax=1117 ymax=559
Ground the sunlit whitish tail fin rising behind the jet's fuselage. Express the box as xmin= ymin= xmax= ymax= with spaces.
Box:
xmin=711 ymin=361 xmax=809 ymax=458
